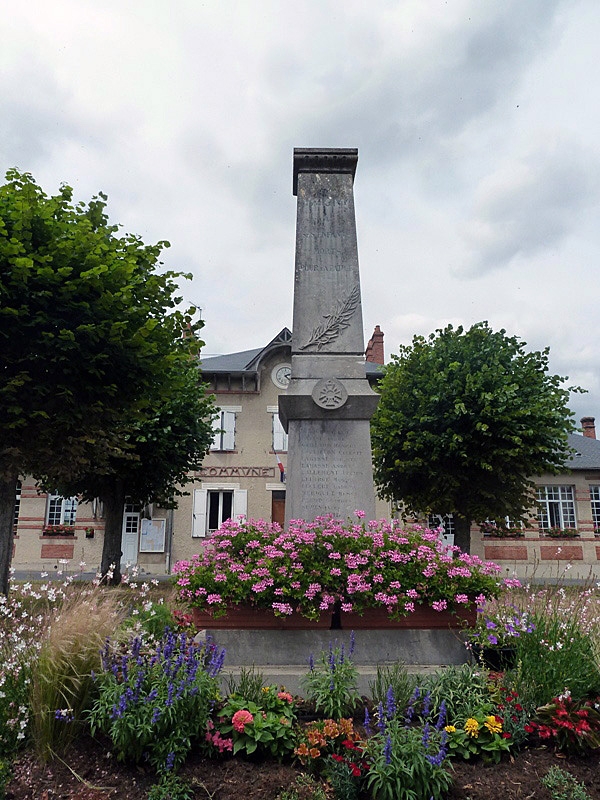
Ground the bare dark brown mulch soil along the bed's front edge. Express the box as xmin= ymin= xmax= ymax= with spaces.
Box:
xmin=6 ymin=739 xmax=600 ymax=800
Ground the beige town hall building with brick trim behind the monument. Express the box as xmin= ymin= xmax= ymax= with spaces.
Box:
xmin=13 ymin=326 xmax=600 ymax=580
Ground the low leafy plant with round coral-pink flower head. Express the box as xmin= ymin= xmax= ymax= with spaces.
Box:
xmin=214 ymin=686 xmax=296 ymax=760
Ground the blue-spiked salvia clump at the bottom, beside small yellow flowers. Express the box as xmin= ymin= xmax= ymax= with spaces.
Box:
xmin=366 ymin=692 xmax=452 ymax=800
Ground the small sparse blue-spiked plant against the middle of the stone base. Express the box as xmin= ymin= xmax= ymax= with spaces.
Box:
xmin=301 ymin=633 xmax=360 ymax=719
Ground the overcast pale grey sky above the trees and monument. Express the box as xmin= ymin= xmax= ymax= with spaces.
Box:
xmin=0 ymin=0 xmax=600 ymax=420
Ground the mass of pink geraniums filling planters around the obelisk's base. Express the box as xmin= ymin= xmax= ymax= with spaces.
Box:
xmin=173 ymin=517 xmax=500 ymax=619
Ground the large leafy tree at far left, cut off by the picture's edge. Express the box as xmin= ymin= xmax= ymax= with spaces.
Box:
xmin=0 ymin=170 xmax=213 ymax=593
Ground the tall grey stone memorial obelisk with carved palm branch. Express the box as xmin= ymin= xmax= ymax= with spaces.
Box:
xmin=279 ymin=148 xmax=379 ymax=527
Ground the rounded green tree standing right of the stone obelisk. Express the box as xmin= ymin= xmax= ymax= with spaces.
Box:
xmin=372 ymin=322 xmax=574 ymax=551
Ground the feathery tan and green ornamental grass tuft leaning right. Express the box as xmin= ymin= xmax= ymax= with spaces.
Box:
xmin=30 ymin=584 xmax=125 ymax=761
